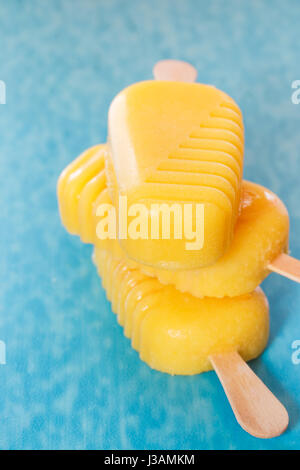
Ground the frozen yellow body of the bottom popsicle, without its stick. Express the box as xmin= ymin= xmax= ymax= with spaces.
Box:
xmin=94 ymin=248 xmax=269 ymax=375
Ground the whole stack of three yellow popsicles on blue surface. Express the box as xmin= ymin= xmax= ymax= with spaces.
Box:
xmin=58 ymin=62 xmax=296 ymax=437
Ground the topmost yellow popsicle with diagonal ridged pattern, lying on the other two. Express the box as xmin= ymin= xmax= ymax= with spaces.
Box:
xmin=106 ymin=81 xmax=244 ymax=270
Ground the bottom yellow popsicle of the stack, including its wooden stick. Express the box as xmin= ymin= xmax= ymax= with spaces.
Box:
xmin=94 ymin=244 xmax=289 ymax=438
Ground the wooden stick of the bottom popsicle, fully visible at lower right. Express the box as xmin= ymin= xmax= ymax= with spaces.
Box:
xmin=210 ymin=352 xmax=289 ymax=439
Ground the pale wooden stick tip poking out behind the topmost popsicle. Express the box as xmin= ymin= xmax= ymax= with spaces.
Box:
xmin=153 ymin=59 xmax=197 ymax=82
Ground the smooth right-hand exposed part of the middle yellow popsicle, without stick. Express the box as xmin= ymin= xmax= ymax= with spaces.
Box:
xmin=143 ymin=180 xmax=289 ymax=297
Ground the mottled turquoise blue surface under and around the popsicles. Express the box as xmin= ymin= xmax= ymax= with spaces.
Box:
xmin=0 ymin=0 xmax=300 ymax=449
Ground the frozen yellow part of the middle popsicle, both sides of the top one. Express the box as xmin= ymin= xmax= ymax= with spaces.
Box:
xmin=58 ymin=146 xmax=289 ymax=297
